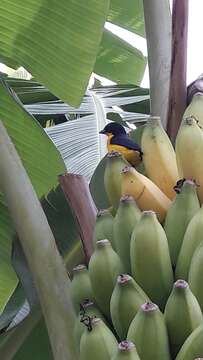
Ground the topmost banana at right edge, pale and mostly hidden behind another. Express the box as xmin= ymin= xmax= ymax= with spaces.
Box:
xmin=183 ymin=93 xmax=203 ymax=126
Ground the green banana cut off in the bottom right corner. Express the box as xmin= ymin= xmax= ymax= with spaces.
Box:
xmin=176 ymin=325 xmax=203 ymax=360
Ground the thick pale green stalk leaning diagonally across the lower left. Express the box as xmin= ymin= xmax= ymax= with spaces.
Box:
xmin=0 ymin=121 xmax=78 ymax=360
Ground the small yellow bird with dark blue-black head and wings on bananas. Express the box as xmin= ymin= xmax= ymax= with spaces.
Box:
xmin=100 ymin=122 xmax=143 ymax=167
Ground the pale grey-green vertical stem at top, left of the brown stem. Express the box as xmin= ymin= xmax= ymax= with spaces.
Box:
xmin=143 ymin=0 xmax=171 ymax=127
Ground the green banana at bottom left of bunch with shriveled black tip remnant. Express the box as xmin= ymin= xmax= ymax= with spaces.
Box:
xmin=80 ymin=318 xmax=118 ymax=360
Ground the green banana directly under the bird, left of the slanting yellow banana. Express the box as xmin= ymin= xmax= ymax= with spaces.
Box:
xmin=104 ymin=151 xmax=129 ymax=210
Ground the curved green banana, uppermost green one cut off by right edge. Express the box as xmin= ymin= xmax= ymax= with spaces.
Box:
xmin=175 ymin=205 xmax=203 ymax=280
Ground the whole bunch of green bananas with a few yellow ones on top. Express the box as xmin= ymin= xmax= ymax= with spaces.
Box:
xmin=70 ymin=96 xmax=203 ymax=360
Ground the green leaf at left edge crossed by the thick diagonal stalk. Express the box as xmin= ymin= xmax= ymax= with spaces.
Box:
xmin=0 ymin=80 xmax=65 ymax=313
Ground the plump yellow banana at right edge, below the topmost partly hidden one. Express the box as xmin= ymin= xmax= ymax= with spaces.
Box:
xmin=176 ymin=117 xmax=203 ymax=203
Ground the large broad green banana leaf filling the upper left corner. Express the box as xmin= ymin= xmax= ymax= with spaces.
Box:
xmin=0 ymin=0 xmax=109 ymax=106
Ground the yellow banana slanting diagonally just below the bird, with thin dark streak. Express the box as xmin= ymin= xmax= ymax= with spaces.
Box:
xmin=122 ymin=167 xmax=171 ymax=222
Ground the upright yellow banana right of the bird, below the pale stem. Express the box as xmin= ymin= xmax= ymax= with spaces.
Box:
xmin=141 ymin=117 xmax=179 ymax=199
